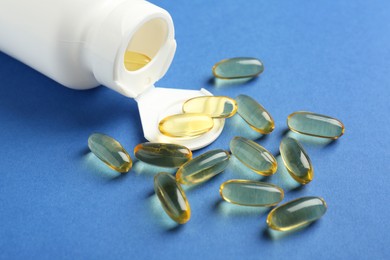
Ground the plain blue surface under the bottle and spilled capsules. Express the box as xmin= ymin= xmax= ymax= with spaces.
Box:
xmin=0 ymin=0 xmax=390 ymax=259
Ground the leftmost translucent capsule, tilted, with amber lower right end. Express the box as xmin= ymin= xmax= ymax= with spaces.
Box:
xmin=88 ymin=133 xmax=133 ymax=173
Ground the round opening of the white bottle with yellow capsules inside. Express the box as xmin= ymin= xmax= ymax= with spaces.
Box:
xmin=124 ymin=18 xmax=168 ymax=71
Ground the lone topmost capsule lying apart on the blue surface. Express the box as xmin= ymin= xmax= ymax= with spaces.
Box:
xmin=213 ymin=58 xmax=264 ymax=79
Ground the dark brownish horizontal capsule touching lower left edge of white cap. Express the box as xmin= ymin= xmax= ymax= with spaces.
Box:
xmin=134 ymin=143 xmax=192 ymax=168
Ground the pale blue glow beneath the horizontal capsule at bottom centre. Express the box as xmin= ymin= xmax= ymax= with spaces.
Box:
xmin=214 ymin=199 xmax=270 ymax=217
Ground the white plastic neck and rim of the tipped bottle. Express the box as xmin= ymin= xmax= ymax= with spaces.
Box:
xmin=84 ymin=0 xmax=176 ymax=98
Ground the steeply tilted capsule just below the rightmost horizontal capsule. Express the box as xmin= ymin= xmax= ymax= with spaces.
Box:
xmin=279 ymin=137 xmax=314 ymax=184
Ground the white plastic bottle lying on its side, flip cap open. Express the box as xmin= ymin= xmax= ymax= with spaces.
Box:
xmin=0 ymin=0 xmax=224 ymax=149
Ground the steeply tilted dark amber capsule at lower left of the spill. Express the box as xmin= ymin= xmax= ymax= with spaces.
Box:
xmin=154 ymin=172 xmax=191 ymax=224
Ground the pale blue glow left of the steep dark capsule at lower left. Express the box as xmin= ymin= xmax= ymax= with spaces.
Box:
xmin=147 ymin=194 xmax=183 ymax=232
